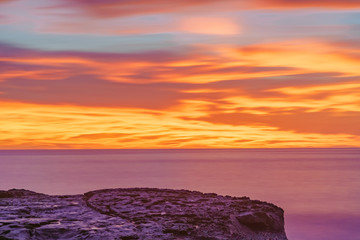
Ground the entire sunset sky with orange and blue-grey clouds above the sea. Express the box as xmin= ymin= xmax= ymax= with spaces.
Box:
xmin=0 ymin=0 xmax=360 ymax=149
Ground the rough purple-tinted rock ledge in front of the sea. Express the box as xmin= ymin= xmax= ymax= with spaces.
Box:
xmin=0 ymin=188 xmax=287 ymax=240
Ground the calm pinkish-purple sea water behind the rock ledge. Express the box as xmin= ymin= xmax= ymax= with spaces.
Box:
xmin=0 ymin=149 xmax=360 ymax=240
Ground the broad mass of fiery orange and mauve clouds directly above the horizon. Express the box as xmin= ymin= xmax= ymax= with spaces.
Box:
xmin=0 ymin=40 xmax=360 ymax=149
